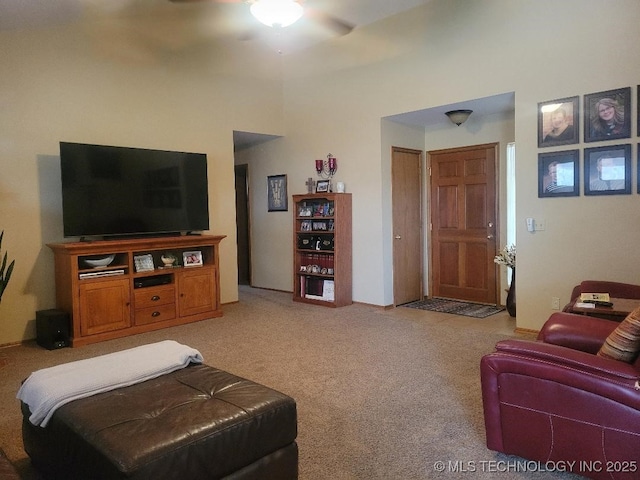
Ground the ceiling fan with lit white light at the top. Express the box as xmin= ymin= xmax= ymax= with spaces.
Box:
xmin=169 ymin=0 xmax=355 ymax=35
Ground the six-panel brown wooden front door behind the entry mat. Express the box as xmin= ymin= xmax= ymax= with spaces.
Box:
xmin=429 ymin=144 xmax=498 ymax=304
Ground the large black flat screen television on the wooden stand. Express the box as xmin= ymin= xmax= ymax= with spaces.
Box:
xmin=60 ymin=142 xmax=209 ymax=238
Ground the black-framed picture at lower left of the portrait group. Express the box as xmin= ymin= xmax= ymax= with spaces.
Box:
xmin=538 ymin=149 xmax=580 ymax=198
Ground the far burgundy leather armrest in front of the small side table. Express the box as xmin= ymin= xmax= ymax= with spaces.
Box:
xmin=538 ymin=312 xmax=620 ymax=354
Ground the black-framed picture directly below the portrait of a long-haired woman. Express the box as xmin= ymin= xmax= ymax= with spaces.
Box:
xmin=584 ymin=145 xmax=631 ymax=195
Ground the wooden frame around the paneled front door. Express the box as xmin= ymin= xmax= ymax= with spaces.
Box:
xmin=425 ymin=142 xmax=502 ymax=305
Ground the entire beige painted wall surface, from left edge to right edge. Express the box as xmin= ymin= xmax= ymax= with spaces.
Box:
xmin=0 ymin=0 xmax=640 ymax=344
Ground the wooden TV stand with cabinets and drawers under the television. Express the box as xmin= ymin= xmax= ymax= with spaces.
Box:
xmin=47 ymin=235 xmax=225 ymax=347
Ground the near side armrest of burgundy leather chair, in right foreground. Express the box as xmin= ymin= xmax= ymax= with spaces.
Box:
xmin=480 ymin=339 xmax=640 ymax=461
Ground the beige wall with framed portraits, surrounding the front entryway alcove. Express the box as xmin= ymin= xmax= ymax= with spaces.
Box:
xmin=244 ymin=0 xmax=640 ymax=329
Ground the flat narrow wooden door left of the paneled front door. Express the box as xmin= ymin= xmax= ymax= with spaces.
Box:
xmin=391 ymin=147 xmax=422 ymax=305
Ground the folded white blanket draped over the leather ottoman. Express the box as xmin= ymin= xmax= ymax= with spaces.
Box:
xmin=17 ymin=340 xmax=202 ymax=427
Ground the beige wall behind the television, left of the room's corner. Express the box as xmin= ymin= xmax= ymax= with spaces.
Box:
xmin=0 ymin=24 xmax=282 ymax=345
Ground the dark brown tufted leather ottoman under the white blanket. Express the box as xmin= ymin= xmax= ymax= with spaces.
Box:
xmin=22 ymin=365 xmax=298 ymax=480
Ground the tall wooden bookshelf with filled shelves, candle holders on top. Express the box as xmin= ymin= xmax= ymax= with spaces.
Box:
xmin=293 ymin=193 xmax=352 ymax=307
